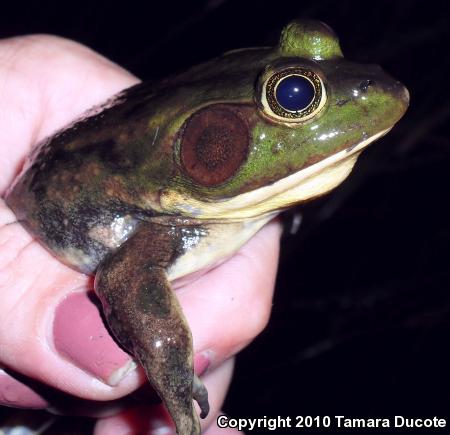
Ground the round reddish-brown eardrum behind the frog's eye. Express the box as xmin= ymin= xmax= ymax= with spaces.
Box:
xmin=180 ymin=105 xmax=249 ymax=187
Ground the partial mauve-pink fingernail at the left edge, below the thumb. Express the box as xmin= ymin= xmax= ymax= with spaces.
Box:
xmin=0 ymin=369 xmax=48 ymax=409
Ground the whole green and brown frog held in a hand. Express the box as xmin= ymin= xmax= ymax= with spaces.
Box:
xmin=6 ymin=19 xmax=409 ymax=435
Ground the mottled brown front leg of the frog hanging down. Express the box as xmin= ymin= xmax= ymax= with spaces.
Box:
xmin=95 ymin=223 xmax=209 ymax=435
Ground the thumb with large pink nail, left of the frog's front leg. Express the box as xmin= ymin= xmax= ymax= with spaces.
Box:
xmin=0 ymin=201 xmax=143 ymax=400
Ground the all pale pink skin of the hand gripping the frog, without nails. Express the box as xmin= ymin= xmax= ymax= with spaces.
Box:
xmin=0 ymin=35 xmax=280 ymax=435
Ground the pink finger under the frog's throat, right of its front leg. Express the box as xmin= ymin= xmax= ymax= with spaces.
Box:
xmin=178 ymin=221 xmax=281 ymax=374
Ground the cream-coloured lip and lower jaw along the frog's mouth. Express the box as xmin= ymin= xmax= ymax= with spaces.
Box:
xmin=161 ymin=127 xmax=392 ymax=221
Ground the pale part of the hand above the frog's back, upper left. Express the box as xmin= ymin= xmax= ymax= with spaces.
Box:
xmin=0 ymin=35 xmax=138 ymax=195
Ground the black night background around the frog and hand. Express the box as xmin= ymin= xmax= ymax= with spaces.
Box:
xmin=0 ymin=0 xmax=450 ymax=433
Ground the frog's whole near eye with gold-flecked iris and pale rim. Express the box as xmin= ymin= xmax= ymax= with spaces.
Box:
xmin=261 ymin=67 xmax=326 ymax=123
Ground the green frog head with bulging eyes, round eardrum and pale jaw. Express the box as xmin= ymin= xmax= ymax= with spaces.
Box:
xmin=142 ymin=21 xmax=409 ymax=219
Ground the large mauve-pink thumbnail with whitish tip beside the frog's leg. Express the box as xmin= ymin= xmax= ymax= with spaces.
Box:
xmin=53 ymin=292 xmax=136 ymax=386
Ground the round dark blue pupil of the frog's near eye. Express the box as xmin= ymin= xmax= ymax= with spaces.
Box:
xmin=275 ymin=75 xmax=314 ymax=112
